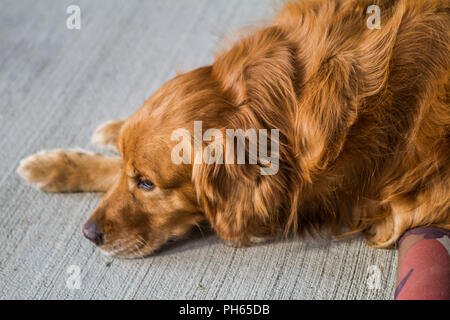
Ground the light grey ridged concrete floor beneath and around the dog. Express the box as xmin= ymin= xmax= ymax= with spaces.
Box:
xmin=0 ymin=0 xmax=396 ymax=299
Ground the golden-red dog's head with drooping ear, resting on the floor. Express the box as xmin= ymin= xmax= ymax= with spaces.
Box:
xmin=84 ymin=60 xmax=294 ymax=257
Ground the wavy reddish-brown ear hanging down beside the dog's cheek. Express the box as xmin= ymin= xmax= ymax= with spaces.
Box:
xmin=192 ymin=106 xmax=298 ymax=245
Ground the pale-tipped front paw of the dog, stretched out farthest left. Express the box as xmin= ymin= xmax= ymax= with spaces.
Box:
xmin=16 ymin=149 xmax=95 ymax=192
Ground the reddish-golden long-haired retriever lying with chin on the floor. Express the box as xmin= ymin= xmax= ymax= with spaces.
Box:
xmin=18 ymin=0 xmax=450 ymax=257
